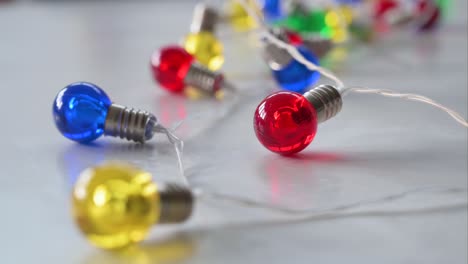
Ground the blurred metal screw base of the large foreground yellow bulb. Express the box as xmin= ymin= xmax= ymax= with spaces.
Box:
xmin=158 ymin=183 xmax=194 ymax=223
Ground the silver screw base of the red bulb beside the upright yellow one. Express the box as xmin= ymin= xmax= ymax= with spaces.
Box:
xmin=184 ymin=63 xmax=224 ymax=95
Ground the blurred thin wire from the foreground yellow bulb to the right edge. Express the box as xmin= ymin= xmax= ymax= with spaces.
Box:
xmin=194 ymin=186 xmax=467 ymax=217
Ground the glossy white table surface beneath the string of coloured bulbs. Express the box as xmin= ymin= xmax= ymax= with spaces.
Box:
xmin=0 ymin=1 xmax=468 ymax=264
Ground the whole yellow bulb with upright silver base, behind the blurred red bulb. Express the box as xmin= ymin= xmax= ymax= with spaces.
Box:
xmin=183 ymin=3 xmax=224 ymax=71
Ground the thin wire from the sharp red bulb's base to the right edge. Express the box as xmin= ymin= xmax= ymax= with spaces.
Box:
xmin=343 ymin=87 xmax=468 ymax=127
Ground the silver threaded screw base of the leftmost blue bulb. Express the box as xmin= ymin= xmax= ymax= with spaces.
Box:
xmin=104 ymin=104 xmax=157 ymax=143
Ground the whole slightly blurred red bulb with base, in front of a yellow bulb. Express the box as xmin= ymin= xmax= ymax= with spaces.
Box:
xmin=151 ymin=46 xmax=231 ymax=95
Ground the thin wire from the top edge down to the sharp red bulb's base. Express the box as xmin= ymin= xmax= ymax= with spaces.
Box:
xmin=238 ymin=0 xmax=344 ymax=89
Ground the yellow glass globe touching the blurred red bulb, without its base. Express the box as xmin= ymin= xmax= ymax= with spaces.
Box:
xmin=184 ymin=31 xmax=224 ymax=71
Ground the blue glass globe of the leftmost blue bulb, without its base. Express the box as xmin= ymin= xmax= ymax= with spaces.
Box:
xmin=52 ymin=82 xmax=112 ymax=143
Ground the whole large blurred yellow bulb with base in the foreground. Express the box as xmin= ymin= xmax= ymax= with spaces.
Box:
xmin=72 ymin=163 xmax=193 ymax=249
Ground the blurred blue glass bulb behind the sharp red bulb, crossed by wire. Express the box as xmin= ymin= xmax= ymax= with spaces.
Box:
xmin=272 ymin=46 xmax=320 ymax=93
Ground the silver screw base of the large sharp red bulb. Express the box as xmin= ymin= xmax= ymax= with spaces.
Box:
xmin=304 ymin=84 xmax=343 ymax=123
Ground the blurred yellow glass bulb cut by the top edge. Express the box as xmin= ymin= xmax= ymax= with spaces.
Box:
xmin=227 ymin=0 xmax=262 ymax=32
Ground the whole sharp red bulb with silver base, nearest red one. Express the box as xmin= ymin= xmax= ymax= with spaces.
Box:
xmin=253 ymin=85 xmax=342 ymax=155
